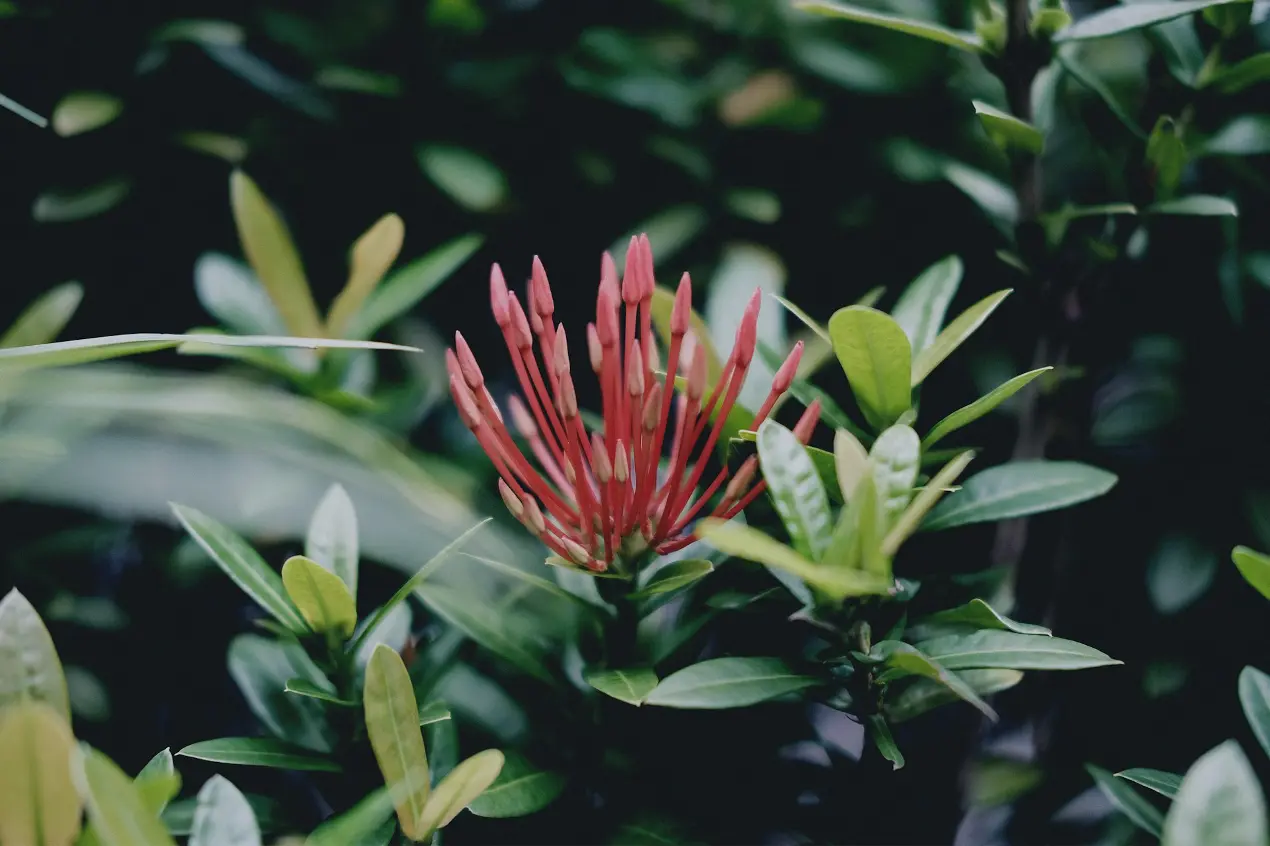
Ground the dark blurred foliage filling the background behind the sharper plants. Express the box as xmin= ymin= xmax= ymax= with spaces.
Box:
xmin=0 ymin=0 xmax=1270 ymax=843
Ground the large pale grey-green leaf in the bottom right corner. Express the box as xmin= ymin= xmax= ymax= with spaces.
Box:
xmin=1160 ymin=741 xmax=1270 ymax=846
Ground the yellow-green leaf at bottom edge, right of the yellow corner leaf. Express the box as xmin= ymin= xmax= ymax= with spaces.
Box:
xmin=74 ymin=744 xmax=175 ymax=846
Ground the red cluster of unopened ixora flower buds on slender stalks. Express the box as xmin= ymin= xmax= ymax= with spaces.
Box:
xmin=446 ymin=235 xmax=819 ymax=572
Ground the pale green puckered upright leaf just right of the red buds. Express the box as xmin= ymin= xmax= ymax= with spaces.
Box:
xmin=757 ymin=419 xmax=833 ymax=560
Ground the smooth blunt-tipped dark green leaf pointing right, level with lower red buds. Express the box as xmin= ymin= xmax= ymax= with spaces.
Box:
xmin=923 ymin=461 xmax=1116 ymax=531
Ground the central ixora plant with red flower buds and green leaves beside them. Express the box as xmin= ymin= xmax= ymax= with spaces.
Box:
xmin=448 ymin=236 xmax=1119 ymax=767
